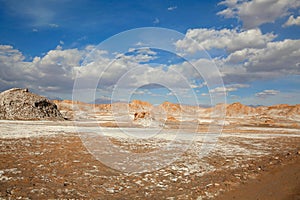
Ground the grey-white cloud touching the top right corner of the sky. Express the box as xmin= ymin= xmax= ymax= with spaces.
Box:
xmin=218 ymin=0 xmax=300 ymax=29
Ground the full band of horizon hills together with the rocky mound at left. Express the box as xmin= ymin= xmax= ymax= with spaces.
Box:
xmin=0 ymin=88 xmax=300 ymax=128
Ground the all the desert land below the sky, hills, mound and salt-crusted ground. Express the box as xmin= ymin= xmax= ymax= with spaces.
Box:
xmin=0 ymin=89 xmax=300 ymax=200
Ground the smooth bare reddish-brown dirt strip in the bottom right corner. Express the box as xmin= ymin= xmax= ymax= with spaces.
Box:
xmin=216 ymin=159 xmax=300 ymax=200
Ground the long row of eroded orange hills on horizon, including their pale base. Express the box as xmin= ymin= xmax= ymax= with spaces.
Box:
xmin=54 ymin=100 xmax=300 ymax=128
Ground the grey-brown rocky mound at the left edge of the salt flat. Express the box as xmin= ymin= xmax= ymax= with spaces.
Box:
xmin=0 ymin=88 xmax=64 ymax=120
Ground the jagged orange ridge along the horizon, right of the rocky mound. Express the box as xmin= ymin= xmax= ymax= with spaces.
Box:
xmin=54 ymin=100 xmax=300 ymax=126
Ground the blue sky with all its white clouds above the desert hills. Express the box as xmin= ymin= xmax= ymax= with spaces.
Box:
xmin=0 ymin=0 xmax=300 ymax=105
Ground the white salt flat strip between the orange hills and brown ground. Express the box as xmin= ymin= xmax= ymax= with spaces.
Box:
xmin=0 ymin=120 xmax=300 ymax=141
